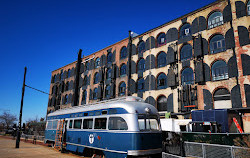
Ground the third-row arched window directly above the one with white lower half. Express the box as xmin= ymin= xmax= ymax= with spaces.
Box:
xmin=212 ymin=60 xmax=228 ymax=81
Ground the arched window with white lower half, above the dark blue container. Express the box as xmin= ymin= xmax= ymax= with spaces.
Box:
xmin=214 ymin=88 xmax=232 ymax=109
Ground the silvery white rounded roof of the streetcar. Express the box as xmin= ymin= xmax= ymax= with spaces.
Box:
xmin=48 ymin=96 xmax=158 ymax=117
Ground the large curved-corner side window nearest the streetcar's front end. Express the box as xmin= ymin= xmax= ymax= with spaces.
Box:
xmin=108 ymin=117 xmax=128 ymax=130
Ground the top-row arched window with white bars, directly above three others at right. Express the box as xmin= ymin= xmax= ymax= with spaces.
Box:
xmin=208 ymin=12 xmax=223 ymax=29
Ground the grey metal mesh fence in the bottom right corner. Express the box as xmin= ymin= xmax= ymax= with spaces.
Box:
xmin=184 ymin=142 xmax=250 ymax=158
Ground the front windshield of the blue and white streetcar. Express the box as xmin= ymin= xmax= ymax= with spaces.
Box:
xmin=138 ymin=115 xmax=160 ymax=131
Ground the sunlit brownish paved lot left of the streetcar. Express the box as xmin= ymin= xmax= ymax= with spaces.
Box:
xmin=0 ymin=136 xmax=80 ymax=158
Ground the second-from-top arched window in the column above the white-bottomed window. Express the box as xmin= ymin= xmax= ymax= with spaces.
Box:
xmin=209 ymin=35 xmax=226 ymax=54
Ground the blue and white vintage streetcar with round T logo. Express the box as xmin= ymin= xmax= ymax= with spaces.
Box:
xmin=45 ymin=97 xmax=162 ymax=158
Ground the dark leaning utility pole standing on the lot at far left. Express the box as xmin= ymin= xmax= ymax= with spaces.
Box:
xmin=16 ymin=67 xmax=27 ymax=148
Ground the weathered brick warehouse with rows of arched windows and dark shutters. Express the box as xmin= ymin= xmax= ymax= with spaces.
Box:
xmin=47 ymin=0 xmax=250 ymax=132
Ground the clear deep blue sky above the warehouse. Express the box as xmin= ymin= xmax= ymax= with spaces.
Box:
xmin=0 ymin=0 xmax=216 ymax=121
